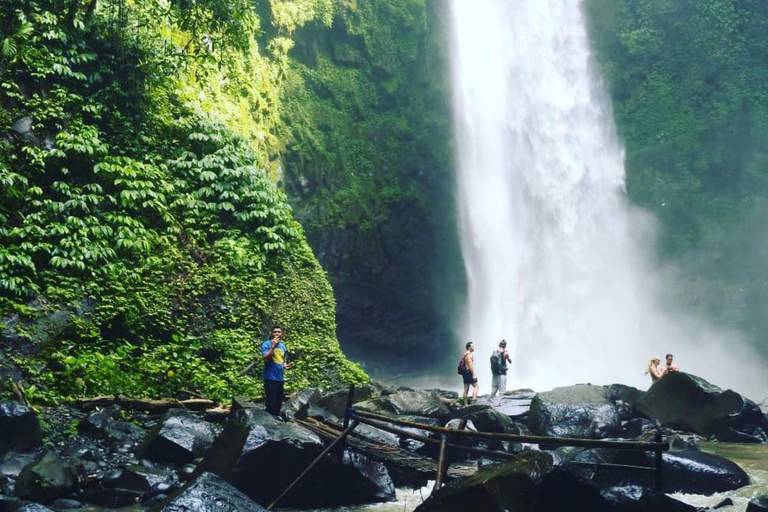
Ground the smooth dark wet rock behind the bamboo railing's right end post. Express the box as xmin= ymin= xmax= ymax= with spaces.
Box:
xmin=593 ymin=451 xmax=749 ymax=495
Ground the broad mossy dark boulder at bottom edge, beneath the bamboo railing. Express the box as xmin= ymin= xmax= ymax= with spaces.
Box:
xmin=416 ymin=451 xmax=611 ymax=512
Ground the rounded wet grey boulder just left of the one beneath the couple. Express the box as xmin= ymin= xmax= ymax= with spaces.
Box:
xmin=528 ymin=384 xmax=621 ymax=439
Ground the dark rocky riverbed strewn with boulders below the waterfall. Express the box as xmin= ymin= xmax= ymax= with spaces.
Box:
xmin=0 ymin=373 xmax=768 ymax=512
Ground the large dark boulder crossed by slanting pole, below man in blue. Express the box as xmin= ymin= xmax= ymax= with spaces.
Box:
xmin=200 ymin=410 xmax=394 ymax=508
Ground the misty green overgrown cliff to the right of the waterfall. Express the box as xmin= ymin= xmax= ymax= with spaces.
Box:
xmin=586 ymin=0 xmax=768 ymax=355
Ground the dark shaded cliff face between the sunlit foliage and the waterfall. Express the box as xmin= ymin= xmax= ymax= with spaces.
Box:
xmin=282 ymin=0 xmax=463 ymax=368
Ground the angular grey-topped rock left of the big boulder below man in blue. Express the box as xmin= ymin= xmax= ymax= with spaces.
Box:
xmin=139 ymin=409 xmax=216 ymax=464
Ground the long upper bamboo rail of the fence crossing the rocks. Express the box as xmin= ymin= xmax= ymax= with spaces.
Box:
xmin=354 ymin=410 xmax=669 ymax=452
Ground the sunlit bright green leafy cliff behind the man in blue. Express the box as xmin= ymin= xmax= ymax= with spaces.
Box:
xmin=0 ymin=0 xmax=367 ymax=400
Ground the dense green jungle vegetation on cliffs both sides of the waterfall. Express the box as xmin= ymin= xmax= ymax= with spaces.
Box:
xmin=0 ymin=0 xmax=768 ymax=400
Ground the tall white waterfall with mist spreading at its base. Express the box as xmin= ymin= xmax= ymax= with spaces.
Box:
xmin=452 ymin=0 xmax=768 ymax=399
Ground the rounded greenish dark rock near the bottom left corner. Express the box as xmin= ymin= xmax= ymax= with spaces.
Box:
xmin=16 ymin=452 xmax=77 ymax=503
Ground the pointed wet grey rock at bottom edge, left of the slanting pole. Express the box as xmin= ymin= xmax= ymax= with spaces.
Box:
xmin=152 ymin=473 xmax=266 ymax=512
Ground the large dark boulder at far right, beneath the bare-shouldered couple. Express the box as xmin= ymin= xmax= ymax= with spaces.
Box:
xmin=637 ymin=372 xmax=768 ymax=442
